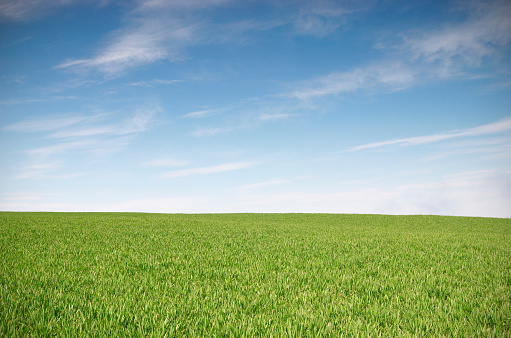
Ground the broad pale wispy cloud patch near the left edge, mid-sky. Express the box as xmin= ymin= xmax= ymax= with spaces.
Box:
xmin=4 ymin=107 xmax=160 ymax=179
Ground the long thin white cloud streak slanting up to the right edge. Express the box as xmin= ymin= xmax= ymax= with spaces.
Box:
xmin=348 ymin=117 xmax=511 ymax=151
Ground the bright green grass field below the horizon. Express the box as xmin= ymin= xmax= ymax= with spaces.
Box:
xmin=0 ymin=212 xmax=511 ymax=337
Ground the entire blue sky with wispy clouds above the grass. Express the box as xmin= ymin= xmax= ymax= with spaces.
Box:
xmin=0 ymin=0 xmax=511 ymax=217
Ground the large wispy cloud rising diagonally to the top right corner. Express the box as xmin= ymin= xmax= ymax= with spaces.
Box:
xmin=289 ymin=0 xmax=511 ymax=100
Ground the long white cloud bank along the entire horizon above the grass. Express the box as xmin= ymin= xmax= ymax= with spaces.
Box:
xmin=0 ymin=169 xmax=511 ymax=217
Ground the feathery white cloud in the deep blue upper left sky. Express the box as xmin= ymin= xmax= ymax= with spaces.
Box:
xmin=56 ymin=11 xmax=280 ymax=76
